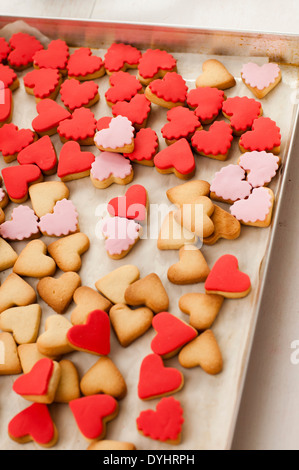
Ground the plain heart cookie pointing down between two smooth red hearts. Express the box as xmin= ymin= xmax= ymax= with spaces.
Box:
xmin=109 ymin=303 xmax=153 ymax=348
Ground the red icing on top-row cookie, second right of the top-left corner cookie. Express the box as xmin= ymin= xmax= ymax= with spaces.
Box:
xmin=67 ymin=47 xmax=104 ymax=77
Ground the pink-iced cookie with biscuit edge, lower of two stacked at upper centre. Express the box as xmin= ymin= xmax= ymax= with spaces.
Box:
xmin=90 ymin=152 xmax=134 ymax=189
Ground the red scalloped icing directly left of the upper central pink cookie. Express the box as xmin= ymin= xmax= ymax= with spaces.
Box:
xmin=57 ymin=107 xmax=97 ymax=140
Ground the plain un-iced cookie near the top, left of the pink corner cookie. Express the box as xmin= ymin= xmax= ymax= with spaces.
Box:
xmin=195 ymin=59 xmax=236 ymax=90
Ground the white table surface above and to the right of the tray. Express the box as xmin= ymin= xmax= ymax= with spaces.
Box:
xmin=0 ymin=0 xmax=299 ymax=450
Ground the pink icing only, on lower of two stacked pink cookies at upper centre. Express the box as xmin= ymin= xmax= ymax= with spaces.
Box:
xmin=91 ymin=152 xmax=132 ymax=181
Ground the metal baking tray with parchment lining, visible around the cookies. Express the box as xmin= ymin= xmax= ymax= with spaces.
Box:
xmin=0 ymin=17 xmax=299 ymax=450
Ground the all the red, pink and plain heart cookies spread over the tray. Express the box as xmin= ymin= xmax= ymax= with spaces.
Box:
xmin=0 ymin=33 xmax=281 ymax=450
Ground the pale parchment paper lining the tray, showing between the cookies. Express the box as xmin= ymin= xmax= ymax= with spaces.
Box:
xmin=0 ymin=21 xmax=298 ymax=450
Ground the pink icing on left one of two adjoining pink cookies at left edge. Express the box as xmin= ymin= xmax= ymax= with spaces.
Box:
xmin=0 ymin=205 xmax=39 ymax=240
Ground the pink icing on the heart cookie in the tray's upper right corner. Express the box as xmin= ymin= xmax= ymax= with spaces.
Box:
xmin=241 ymin=62 xmax=280 ymax=90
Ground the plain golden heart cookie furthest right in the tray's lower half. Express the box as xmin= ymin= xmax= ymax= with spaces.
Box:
xmin=178 ymin=330 xmax=223 ymax=375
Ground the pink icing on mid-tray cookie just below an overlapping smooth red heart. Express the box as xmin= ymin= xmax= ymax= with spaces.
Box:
xmin=102 ymin=217 xmax=141 ymax=255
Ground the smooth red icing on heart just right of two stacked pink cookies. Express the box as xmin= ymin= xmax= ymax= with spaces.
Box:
xmin=154 ymin=139 xmax=195 ymax=175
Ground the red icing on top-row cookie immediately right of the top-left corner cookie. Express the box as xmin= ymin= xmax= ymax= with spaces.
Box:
xmin=33 ymin=39 xmax=69 ymax=70
